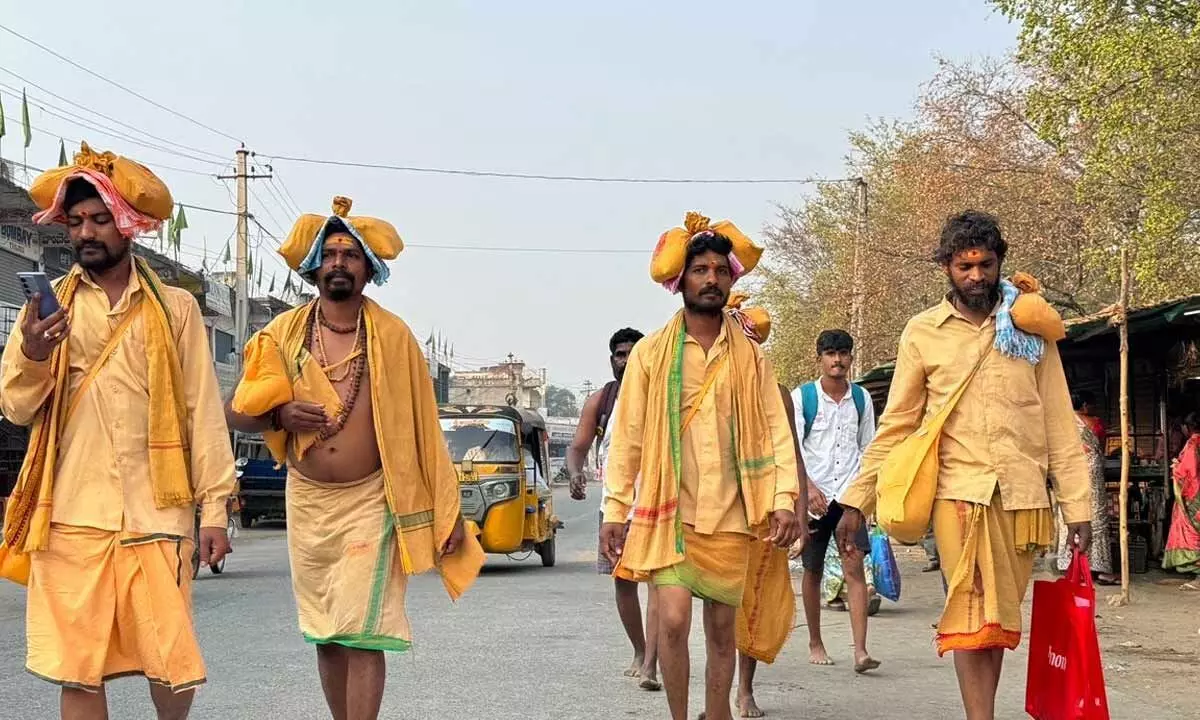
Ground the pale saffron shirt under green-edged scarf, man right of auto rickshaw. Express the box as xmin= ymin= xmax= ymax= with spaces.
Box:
xmin=604 ymin=324 xmax=799 ymax=535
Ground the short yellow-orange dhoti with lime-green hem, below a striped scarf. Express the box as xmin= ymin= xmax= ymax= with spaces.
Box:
xmin=650 ymin=524 xmax=751 ymax=607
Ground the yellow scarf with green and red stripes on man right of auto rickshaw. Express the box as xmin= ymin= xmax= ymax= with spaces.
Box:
xmin=618 ymin=311 xmax=776 ymax=577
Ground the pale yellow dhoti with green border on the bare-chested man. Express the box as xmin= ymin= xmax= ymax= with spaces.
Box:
xmin=287 ymin=469 xmax=412 ymax=652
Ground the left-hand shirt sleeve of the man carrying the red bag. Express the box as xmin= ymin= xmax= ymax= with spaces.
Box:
xmin=838 ymin=328 xmax=926 ymax=515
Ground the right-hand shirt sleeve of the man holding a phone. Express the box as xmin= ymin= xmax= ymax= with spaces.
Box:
xmin=179 ymin=298 xmax=234 ymax=528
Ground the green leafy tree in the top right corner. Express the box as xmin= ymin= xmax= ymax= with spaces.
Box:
xmin=991 ymin=0 xmax=1200 ymax=302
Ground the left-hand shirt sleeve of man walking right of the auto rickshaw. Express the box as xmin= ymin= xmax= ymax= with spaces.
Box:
xmin=604 ymin=342 xmax=652 ymax=522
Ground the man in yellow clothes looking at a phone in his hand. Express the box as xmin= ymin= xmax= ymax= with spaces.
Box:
xmin=0 ymin=144 xmax=234 ymax=719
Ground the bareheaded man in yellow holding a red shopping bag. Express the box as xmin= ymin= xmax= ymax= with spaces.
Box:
xmin=838 ymin=211 xmax=1092 ymax=720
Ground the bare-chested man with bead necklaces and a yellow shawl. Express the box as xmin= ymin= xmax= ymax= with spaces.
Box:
xmin=228 ymin=197 xmax=484 ymax=720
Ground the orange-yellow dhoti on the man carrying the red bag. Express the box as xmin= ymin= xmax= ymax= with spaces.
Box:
xmin=932 ymin=492 xmax=1052 ymax=655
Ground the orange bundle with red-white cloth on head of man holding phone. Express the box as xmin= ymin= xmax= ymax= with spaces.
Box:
xmin=29 ymin=143 xmax=175 ymax=238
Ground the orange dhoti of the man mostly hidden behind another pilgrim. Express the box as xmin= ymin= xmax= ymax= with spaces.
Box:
xmin=737 ymin=540 xmax=796 ymax=664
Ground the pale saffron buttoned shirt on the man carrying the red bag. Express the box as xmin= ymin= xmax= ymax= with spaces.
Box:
xmin=841 ymin=299 xmax=1092 ymax=523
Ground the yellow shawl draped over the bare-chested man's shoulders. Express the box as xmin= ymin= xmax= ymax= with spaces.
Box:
xmin=233 ymin=299 xmax=484 ymax=599
